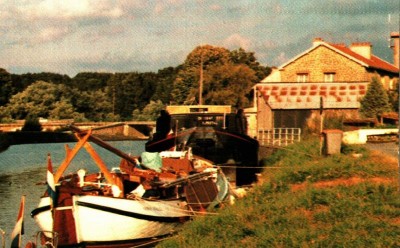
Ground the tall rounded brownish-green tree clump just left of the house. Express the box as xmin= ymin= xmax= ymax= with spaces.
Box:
xmin=171 ymin=45 xmax=267 ymax=107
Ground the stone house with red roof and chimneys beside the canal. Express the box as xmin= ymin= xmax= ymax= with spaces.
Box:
xmin=255 ymin=33 xmax=399 ymax=134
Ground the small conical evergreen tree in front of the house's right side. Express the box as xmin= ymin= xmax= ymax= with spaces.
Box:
xmin=360 ymin=77 xmax=391 ymax=118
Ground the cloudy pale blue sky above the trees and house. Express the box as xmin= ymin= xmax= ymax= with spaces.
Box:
xmin=0 ymin=0 xmax=400 ymax=77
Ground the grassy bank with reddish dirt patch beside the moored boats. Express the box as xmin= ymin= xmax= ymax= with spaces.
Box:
xmin=158 ymin=141 xmax=400 ymax=247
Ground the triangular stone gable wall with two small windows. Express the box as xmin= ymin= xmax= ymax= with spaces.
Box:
xmin=281 ymin=46 xmax=369 ymax=82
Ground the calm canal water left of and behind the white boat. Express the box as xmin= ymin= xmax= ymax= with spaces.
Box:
xmin=0 ymin=141 xmax=146 ymax=247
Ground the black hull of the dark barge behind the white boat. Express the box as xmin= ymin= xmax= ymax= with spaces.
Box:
xmin=146 ymin=126 xmax=260 ymax=185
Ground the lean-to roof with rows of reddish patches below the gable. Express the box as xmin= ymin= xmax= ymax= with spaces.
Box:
xmin=256 ymin=82 xmax=368 ymax=109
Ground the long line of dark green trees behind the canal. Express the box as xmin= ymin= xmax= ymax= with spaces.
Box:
xmin=0 ymin=45 xmax=271 ymax=123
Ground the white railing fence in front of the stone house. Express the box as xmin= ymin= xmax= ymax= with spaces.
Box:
xmin=257 ymin=128 xmax=301 ymax=146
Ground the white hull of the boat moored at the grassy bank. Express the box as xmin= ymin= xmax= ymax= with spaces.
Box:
xmin=32 ymin=195 xmax=192 ymax=245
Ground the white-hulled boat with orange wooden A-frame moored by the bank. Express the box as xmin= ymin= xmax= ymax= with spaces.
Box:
xmin=31 ymin=127 xmax=229 ymax=247
